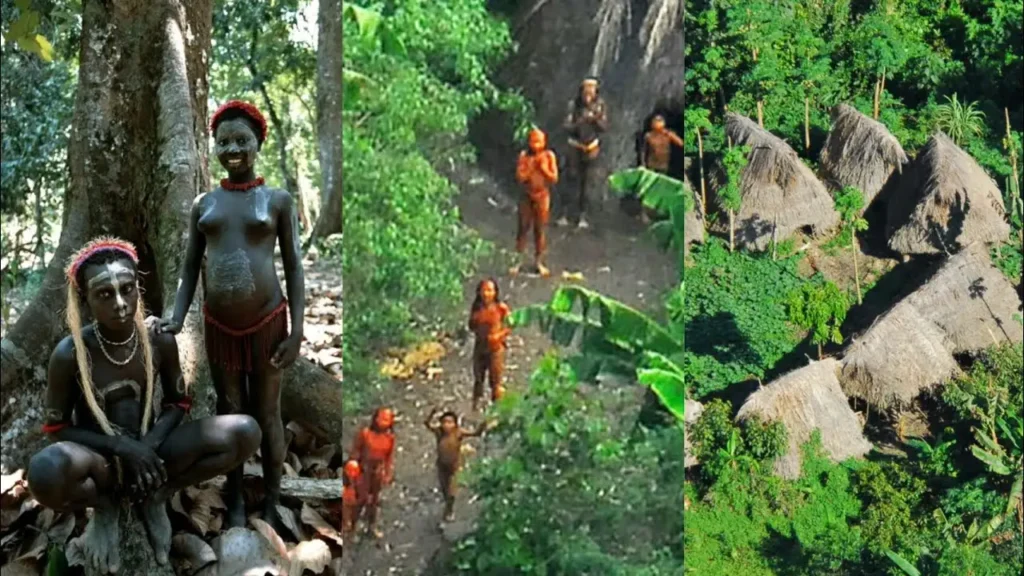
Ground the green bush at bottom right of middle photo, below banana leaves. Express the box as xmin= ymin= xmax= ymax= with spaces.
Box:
xmin=444 ymin=356 xmax=683 ymax=576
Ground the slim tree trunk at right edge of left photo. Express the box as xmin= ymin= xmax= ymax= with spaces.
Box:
xmin=307 ymin=0 xmax=342 ymax=247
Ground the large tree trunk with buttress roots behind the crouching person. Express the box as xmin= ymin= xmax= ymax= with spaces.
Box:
xmin=0 ymin=0 xmax=341 ymax=469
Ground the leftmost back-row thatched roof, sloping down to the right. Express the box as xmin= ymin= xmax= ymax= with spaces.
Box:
xmin=709 ymin=112 xmax=840 ymax=250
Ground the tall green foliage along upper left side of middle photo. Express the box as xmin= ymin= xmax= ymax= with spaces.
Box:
xmin=342 ymin=0 xmax=520 ymax=358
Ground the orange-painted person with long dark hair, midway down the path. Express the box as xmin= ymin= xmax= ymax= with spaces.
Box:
xmin=469 ymin=278 xmax=512 ymax=411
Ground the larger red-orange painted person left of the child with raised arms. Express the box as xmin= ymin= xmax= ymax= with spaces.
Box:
xmin=349 ymin=407 xmax=394 ymax=538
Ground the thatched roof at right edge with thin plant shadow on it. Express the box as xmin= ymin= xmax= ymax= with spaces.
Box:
xmin=906 ymin=244 xmax=1024 ymax=354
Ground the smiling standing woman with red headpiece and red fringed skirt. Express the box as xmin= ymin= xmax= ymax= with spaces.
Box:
xmin=162 ymin=100 xmax=305 ymax=531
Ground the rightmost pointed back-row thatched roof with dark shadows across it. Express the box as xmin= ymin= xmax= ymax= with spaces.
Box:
xmin=888 ymin=132 xmax=1010 ymax=254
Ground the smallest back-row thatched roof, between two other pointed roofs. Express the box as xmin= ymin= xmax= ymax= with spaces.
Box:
xmin=820 ymin=104 xmax=909 ymax=207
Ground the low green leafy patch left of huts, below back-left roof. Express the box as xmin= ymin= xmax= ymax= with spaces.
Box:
xmin=667 ymin=239 xmax=804 ymax=398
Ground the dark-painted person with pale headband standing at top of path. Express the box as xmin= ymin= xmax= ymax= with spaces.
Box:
xmin=558 ymin=78 xmax=608 ymax=229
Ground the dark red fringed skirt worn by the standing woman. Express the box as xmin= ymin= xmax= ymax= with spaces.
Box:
xmin=203 ymin=300 xmax=288 ymax=372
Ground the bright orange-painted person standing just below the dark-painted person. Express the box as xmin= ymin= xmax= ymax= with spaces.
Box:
xmin=511 ymin=128 xmax=558 ymax=277
